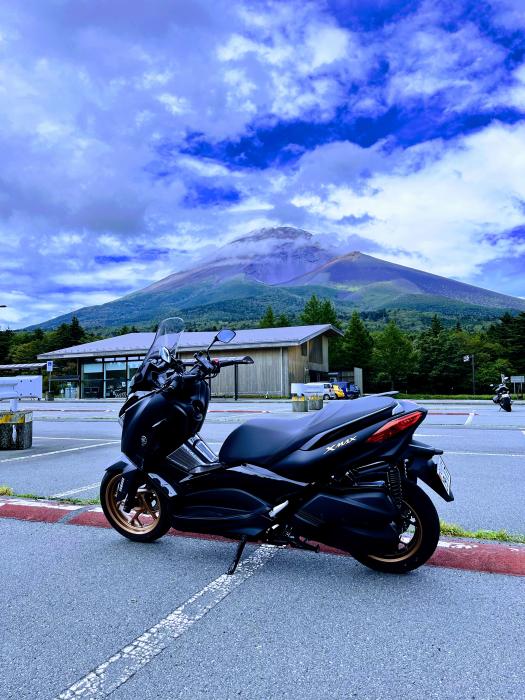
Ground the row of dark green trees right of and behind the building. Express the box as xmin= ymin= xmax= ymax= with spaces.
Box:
xmin=260 ymin=294 xmax=525 ymax=394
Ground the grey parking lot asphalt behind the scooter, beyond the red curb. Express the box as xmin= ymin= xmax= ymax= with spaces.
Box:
xmin=0 ymin=401 xmax=525 ymax=534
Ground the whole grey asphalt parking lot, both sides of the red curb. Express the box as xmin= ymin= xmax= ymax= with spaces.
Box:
xmin=0 ymin=401 xmax=525 ymax=700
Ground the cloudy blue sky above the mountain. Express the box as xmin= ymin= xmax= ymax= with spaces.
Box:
xmin=0 ymin=0 xmax=525 ymax=328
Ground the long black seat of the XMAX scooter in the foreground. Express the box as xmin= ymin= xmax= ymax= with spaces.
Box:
xmin=219 ymin=396 xmax=397 ymax=467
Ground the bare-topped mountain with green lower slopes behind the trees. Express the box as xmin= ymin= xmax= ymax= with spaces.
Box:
xmin=31 ymin=227 xmax=525 ymax=328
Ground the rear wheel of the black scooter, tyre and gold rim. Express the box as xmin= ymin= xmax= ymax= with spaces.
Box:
xmin=352 ymin=481 xmax=440 ymax=574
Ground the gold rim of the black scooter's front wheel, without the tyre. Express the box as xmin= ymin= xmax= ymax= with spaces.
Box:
xmin=105 ymin=474 xmax=161 ymax=535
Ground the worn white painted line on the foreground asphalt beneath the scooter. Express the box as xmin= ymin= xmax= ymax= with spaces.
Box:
xmin=55 ymin=545 xmax=278 ymax=700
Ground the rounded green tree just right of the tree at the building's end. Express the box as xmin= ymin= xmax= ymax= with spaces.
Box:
xmin=374 ymin=321 xmax=414 ymax=389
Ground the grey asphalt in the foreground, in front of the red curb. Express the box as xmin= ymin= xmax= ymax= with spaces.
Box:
xmin=0 ymin=520 xmax=525 ymax=700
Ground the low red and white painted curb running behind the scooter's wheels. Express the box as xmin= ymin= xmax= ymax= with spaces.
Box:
xmin=0 ymin=497 xmax=525 ymax=576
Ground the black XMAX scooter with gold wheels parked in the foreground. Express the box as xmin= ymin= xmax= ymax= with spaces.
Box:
xmin=100 ymin=319 xmax=453 ymax=573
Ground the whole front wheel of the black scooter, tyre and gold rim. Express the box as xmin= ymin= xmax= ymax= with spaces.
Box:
xmin=100 ymin=472 xmax=171 ymax=542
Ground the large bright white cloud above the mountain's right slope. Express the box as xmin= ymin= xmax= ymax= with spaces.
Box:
xmin=291 ymin=124 xmax=525 ymax=280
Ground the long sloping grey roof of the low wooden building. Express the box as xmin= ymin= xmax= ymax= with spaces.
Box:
xmin=38 ymin=323 xmax=342 ymax=360
